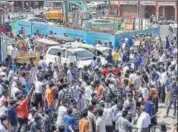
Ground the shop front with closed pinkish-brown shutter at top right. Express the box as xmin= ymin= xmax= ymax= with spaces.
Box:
xmin=120 ymin=1 xmax=138 ymax=18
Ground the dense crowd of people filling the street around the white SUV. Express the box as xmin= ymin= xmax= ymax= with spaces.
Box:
xmin=0 ymin=29 xmax=178 ymax=132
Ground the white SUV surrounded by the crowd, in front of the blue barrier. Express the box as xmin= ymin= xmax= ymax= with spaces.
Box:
xmin=45 ymin=46 xmax=101 ymax=68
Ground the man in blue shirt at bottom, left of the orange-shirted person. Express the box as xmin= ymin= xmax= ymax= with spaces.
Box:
xmin=64 ymin=108 xmax=76 ymax=132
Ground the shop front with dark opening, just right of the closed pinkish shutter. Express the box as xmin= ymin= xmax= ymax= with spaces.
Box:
xmin=140 ymin=1 xmax=156 ymax=18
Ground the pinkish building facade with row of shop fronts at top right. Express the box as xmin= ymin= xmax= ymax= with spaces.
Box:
xmin=111 ymin=1 xmax=178 ymax=20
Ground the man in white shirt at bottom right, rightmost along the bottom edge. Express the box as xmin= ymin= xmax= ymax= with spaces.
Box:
xmin=137 ymin=106 xmax=151 ymax=132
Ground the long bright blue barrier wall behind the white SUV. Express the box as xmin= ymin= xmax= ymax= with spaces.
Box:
xmin=13 ymin=20 xmax=159 ymax=47
